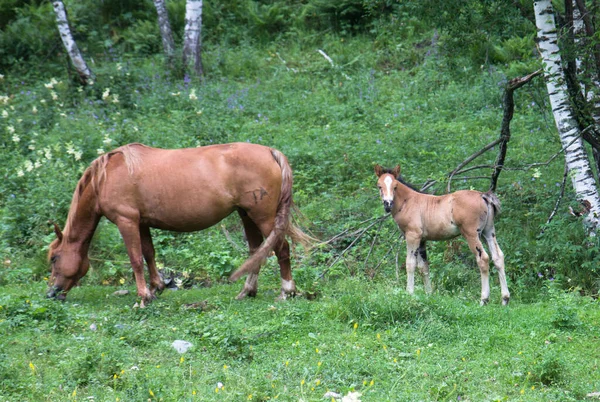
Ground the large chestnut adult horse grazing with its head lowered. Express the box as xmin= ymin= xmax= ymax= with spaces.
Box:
xmin=48 ymin=143 xmax=309 ymax=304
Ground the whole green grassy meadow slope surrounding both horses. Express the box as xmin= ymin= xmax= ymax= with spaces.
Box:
xmin=0 ymin=19 xmax=600 ymax=401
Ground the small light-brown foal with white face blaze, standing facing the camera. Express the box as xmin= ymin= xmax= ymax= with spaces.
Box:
xmin=375 ymin=165 xmax=510 ymax=305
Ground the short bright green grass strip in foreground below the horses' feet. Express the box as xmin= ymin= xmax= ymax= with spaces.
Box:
xmin=0 ymin=271 xmax=600 ymax=401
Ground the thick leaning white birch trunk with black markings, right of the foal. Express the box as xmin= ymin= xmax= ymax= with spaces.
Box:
xmin=533 ymin=0 xmax=600 ymax=235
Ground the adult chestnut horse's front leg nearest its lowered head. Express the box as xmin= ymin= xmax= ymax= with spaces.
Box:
xmin=116 ymin=219 xmax=154 ymax=307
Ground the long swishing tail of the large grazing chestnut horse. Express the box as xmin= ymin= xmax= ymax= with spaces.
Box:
xmin=229 ymin=149 xmax=314 ymax=281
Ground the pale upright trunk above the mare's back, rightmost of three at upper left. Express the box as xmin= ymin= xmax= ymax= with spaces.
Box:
xmin=183 ymin=0 xmax=204 ymax=76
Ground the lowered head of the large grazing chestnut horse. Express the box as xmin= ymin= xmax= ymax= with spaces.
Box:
xmin=46 ymin=224 xmax=90 ymax=300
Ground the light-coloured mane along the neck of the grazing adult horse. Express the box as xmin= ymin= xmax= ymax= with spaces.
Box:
xmin=64 ymin=143 xmax=147 ymax=237
